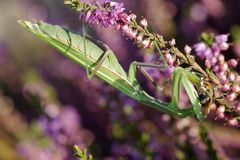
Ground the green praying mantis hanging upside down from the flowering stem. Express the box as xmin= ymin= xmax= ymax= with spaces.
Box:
xmin=18 ymin=20 xmax=205 ymax=120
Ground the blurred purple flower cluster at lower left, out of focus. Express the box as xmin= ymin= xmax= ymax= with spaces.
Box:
xmin=39 ymin=105 xmax=92 ymax=146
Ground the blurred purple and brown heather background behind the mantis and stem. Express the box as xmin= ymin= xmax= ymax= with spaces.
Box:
xmin=0 ymin=0 xmax=240 ymax=160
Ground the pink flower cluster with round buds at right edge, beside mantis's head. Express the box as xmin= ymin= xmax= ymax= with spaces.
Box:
xmin=194 ymin=34 xmax=240 ymax=126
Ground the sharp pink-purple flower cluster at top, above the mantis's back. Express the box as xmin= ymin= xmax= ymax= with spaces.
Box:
xmin=77 ymin=1 xmax=161 ymax=48
